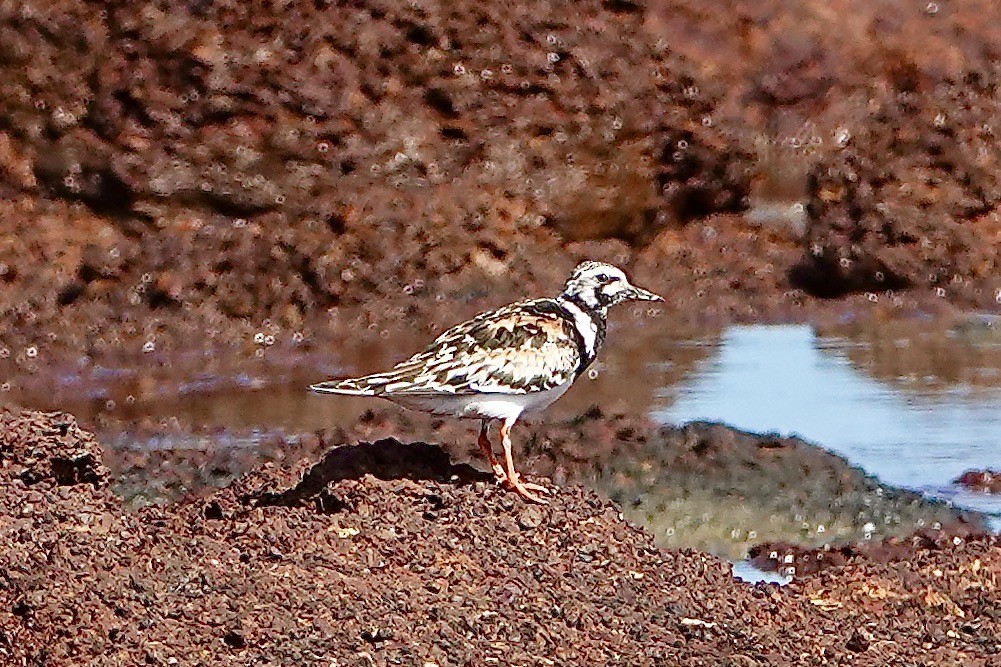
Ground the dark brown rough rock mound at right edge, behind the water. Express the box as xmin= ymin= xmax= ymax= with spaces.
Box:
xmin=798 ymin=72 xmax=1001 ymax=294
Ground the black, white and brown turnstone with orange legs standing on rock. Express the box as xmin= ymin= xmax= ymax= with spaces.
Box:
xmin=309 ymin=261 xmax=664 ymax=503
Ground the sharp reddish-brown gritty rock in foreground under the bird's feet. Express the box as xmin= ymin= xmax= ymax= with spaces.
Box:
xmin=0 ymin=413 xmax=1001 ymax=666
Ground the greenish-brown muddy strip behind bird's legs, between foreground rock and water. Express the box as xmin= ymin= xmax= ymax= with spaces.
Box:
xmin=82 ymin=406 xmax=985 ymax=559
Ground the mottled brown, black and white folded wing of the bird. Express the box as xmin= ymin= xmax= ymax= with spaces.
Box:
xmin=366 ymin=299 xmax=581 ymax=395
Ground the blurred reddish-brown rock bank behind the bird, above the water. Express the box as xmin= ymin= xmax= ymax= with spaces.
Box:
xmin=0 ymin=0 xmax=1001 ymax=404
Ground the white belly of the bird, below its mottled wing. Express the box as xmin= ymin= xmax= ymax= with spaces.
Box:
xmin=382 ymin=384 xmax=570 ymax=420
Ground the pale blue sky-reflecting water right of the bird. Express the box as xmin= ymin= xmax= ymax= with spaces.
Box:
xmin=653 ymin=325 xmax=1001 ymax=527
